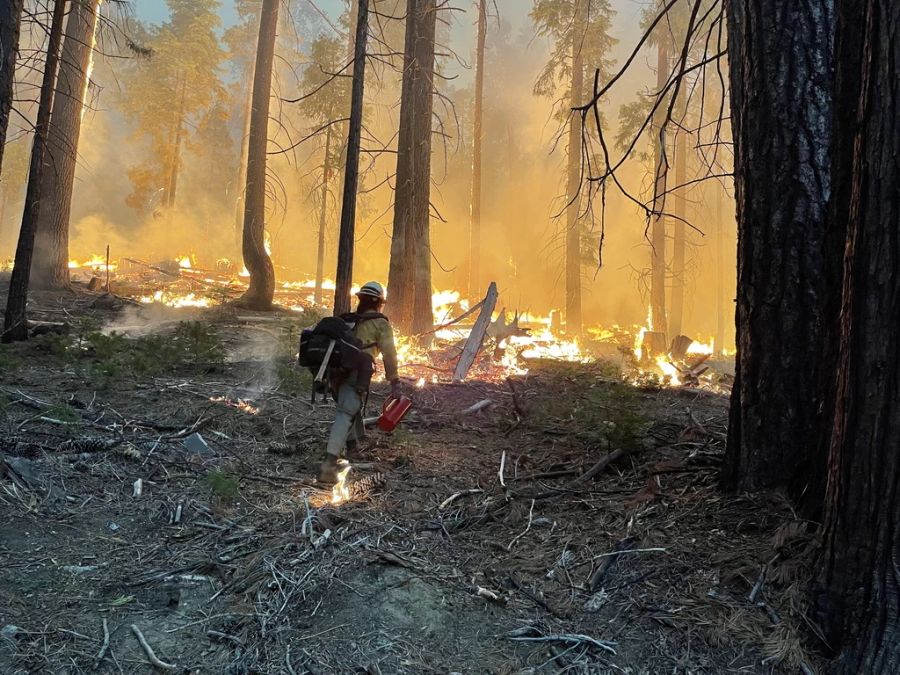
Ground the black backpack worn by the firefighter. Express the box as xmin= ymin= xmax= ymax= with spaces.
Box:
xmin=298 ymin=312 xmax=387 ymax=395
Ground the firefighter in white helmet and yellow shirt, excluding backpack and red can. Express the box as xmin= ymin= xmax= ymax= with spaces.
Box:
xmin=319 ymin=281 xmax=400 ymax=484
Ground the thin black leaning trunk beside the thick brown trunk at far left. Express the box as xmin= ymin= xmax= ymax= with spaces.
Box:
xmin=2 ymin=0 xmax=66 ymax=342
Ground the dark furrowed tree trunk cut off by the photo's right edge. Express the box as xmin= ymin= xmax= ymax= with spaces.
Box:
xmin=815 ymin=0 xmax=900 ymax=674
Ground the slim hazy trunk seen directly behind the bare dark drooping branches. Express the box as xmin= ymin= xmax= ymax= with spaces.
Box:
xmin=650 ymin=40 xmax=669 ymax=342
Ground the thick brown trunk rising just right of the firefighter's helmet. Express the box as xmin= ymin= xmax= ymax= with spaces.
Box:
xmin=388 ymin=0 xmax=437 ymax=334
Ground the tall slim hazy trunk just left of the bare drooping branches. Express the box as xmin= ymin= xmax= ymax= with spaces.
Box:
xmin=566 ymin=0 xmax=590 ymax=335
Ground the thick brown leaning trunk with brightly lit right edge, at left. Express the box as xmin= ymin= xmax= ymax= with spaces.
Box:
xmin=31 ymin=0 xmax=100 ymax=289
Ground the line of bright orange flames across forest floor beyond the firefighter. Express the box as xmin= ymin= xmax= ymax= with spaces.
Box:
xmin=69 ymin=254 xmax=734 ymax=388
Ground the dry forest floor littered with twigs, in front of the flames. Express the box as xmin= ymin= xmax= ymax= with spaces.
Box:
xmin=0 ymin=286 xmax=813 ymax=674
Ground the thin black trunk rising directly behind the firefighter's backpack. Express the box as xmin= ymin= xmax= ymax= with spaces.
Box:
xmin=334 ymin=0 xmax=369 ymax=315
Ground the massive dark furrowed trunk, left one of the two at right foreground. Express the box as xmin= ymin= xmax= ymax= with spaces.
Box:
xmin=722 ymin=0 xmax=834 ymax=494
